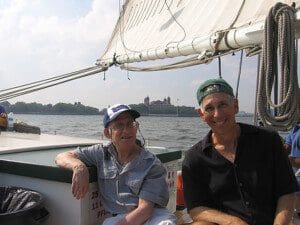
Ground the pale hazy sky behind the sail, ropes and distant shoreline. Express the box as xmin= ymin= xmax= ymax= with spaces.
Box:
xmin=0 ymin=0 xmax=278 ymax=112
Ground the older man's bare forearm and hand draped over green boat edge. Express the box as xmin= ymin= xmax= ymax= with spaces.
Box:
xmin=55 ymin=151 xmax=89 ymax=199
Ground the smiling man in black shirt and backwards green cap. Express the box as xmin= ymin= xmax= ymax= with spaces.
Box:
xmin=182 ymin=79 xmax=297 ymax=225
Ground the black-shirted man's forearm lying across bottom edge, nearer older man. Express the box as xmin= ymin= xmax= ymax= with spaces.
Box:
xmin=189 ymin=207 xmax=248 ymax=225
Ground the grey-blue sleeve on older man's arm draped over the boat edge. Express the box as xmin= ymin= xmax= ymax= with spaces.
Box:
xmin=75 ymin=145 xmax=103 ymax=166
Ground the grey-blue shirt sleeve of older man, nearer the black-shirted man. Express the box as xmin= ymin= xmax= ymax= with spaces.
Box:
xmin=139 ymin=158 xmax=169 ymax=207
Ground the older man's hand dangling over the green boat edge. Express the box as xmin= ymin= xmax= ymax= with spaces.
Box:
xmin=72 ymin=164 xmax=89 ymax=199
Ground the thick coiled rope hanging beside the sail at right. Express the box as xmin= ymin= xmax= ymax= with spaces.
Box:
xmin=257 ymin=3 xmax=300 ymax=131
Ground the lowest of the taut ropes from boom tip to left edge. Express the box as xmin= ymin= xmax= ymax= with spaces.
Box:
xmin=0 ymin=68 xmax=106 ymax=101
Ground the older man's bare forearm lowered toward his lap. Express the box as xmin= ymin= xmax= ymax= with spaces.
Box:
xmin=116 ymin=198 xmax=154 ymax=225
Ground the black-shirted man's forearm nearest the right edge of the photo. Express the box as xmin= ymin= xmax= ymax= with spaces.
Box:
xmin=274 ymin=193 xmax=296 ymax=225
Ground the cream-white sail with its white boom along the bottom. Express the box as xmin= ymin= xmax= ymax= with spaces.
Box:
xmin=97 ymin=0 xmax=300 ymax=66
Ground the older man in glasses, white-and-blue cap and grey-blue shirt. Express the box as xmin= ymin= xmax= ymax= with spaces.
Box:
xmin=56 ymin=104 xmax=176 ymax=225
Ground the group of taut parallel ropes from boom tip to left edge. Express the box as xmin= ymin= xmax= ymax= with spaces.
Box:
xmin=0 ymin=66 xmax=107 ymax=102
